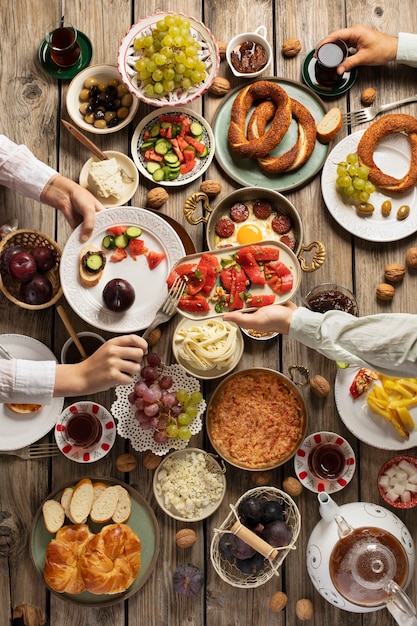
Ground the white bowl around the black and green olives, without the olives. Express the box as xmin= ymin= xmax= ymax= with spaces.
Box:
xmin=66 ymin=64 xmax=139 ymax=135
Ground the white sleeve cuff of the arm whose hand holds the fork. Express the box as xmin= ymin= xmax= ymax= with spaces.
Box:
xmin=0 ymin=359 xmax=56 ymax=404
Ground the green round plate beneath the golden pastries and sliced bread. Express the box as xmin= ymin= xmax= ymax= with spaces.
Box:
xmin=30 ymin=476 xmax=160 ymax=608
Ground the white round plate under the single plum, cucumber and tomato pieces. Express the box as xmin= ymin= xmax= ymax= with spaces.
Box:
xmin=60 ymin=206 xmax=185 ymax=333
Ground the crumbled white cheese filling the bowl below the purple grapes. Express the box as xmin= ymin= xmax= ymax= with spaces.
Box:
xmin=155 ymin=452 xmax=224 ymax=519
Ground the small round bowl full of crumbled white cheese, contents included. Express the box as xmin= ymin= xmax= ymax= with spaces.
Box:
xmin=153 ymin=448 xmax=226 ymax=522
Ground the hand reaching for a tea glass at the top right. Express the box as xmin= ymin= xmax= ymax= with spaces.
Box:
xmin=316 ymin=24 xmax=398 ymax=76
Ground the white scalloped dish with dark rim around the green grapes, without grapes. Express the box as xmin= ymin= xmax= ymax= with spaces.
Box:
xmin=117 ymin=11 xmax=220 ymax=107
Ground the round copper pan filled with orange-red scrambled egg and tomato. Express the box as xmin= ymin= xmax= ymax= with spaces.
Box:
xmin=206 ymin=368 xmax=307 ymax=471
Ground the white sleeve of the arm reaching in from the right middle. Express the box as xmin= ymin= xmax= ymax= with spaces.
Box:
xmin=289 ymin=307 xmax=417 ymax=378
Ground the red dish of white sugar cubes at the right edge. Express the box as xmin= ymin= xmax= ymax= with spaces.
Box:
xmin=377 ymin=455 xmax=417 ymax=509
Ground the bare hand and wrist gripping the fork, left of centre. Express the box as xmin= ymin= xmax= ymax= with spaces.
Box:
xmin=54 ymin=335 xmax=148 ymax=397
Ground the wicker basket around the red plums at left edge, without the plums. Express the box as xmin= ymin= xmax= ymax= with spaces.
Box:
xmin=0 ymin=229 xmax=62 ymax=311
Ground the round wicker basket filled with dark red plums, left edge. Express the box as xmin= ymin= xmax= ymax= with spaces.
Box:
xmin=0 ymin=229 xmax=62 ymax=310
